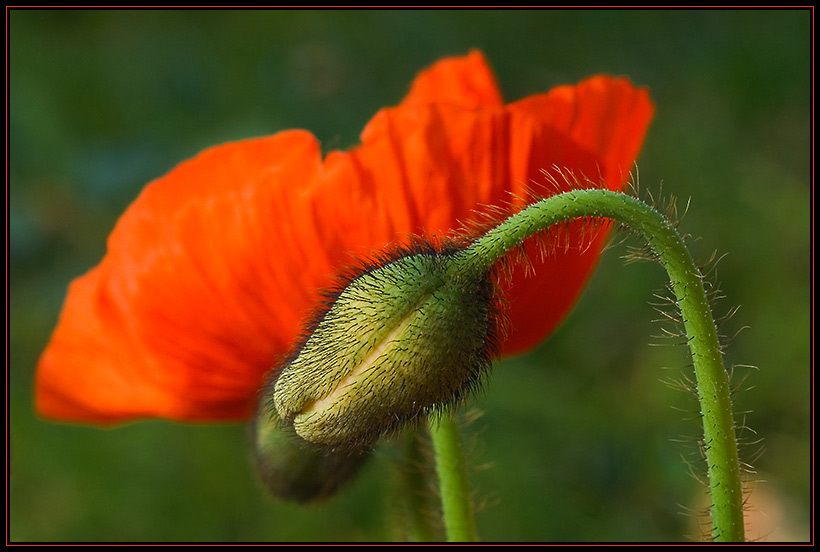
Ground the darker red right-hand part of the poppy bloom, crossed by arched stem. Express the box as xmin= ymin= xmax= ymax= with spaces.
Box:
xmin=501 ymin=76 xmax=654 ymax=355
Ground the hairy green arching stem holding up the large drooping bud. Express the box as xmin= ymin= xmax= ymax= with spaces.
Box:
xmin=453 ymin=190 xmax=744 ymax=541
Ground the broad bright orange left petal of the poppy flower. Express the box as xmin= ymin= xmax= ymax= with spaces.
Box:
xmin=37 ymin=131 xmax=330 ymax=422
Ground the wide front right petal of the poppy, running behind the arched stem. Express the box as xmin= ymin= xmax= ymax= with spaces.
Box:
xmin=317 ymin=76 xmax=654 ymax=355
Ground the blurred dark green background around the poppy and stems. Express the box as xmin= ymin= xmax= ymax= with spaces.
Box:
xmin=8 ymin=10 xmax=812 ymax=541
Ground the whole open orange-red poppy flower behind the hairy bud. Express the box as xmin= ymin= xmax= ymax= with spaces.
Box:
xmin=36 ymin=52 xmax=653 ymax=424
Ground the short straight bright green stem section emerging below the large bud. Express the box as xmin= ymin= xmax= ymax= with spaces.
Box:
xmin=430 ymin=415 xmax=476 ymax=542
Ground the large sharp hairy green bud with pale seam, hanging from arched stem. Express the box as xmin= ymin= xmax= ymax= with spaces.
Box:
xmin=273 ymin=251 xmax=495 ymax=447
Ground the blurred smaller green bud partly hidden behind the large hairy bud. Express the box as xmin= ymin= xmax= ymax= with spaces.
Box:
xmin=253 ymin=407 xmax=369 ymax=502
